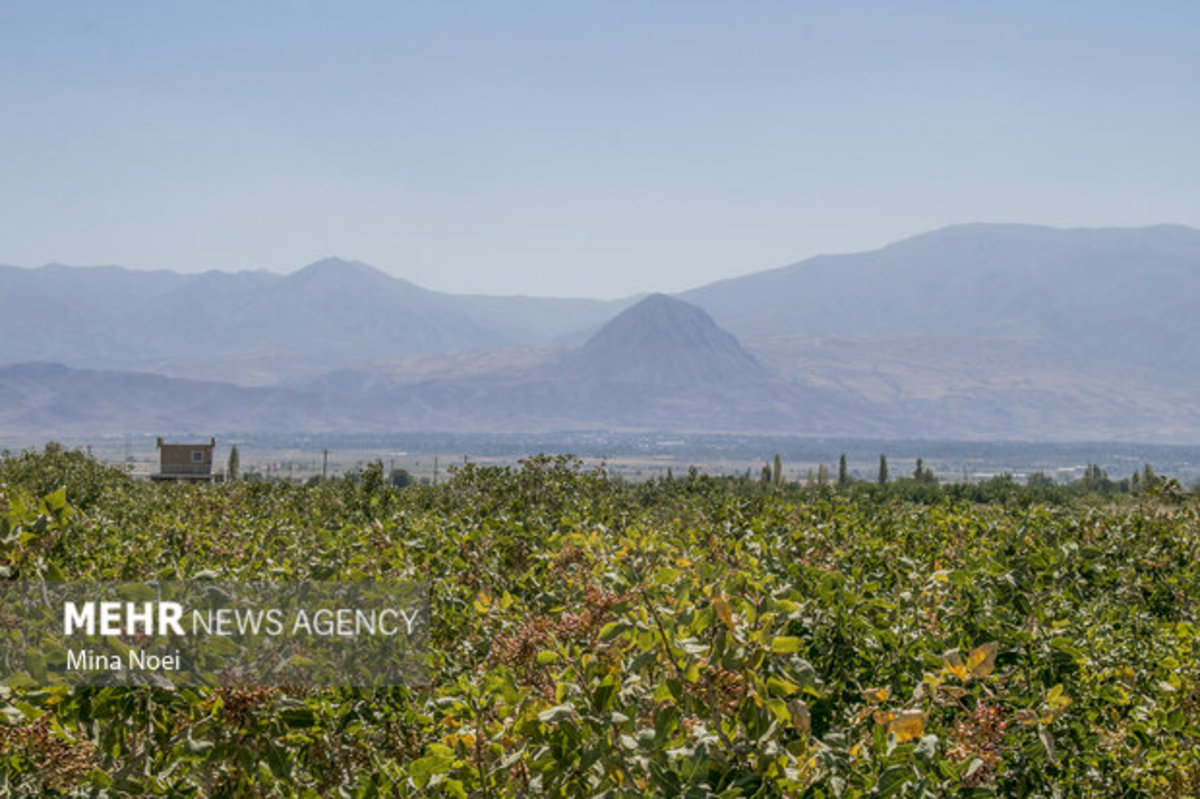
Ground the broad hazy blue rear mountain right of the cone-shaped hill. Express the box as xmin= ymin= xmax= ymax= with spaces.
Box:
xmin=680 ymin=224 xmax=1200 ymax=371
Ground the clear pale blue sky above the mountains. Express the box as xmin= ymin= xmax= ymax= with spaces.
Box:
xmin=0 ymin=0 xmax=1200 ymax=298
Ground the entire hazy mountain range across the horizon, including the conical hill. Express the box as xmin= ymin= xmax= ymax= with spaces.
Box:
xmin=0 ymin=224 xmax=1200 ymax=443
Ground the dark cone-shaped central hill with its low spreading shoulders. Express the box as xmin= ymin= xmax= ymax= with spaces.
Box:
xmin=297 ymin=295 xmax=901 ymax=434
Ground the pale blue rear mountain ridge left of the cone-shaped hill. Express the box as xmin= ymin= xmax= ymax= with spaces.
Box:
xmin=0 ymin=258 xmax=625 ymax=384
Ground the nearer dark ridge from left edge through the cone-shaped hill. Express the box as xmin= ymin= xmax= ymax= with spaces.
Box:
xmin=0 ymin=295 xmax=913 ymax=435
